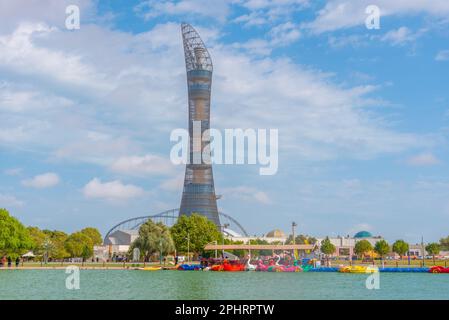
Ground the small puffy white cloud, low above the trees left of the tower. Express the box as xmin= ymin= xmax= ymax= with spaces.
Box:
xmin=83 ymin=178 xmax=145 ymax=200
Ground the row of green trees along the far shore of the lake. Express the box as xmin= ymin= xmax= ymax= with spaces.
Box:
xmin=0 ymin=209 xmax=449 ymax=260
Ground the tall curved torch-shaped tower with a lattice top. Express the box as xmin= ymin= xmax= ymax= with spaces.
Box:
xmin=179 ymin=23 xmax=220 ymax=226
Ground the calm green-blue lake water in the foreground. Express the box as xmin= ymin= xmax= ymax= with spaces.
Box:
xmin=0 ymin=270 xmax=449 ymax=299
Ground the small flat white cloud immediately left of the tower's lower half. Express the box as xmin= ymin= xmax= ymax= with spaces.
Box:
xmin=109 ymin=154 xmax=174 ymax=176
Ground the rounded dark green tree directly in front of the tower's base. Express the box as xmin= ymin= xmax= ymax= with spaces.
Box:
xmin=170 ymin=214 xmax=222 ymax=254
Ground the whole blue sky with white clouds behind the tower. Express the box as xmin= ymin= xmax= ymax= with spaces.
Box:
xmin=0 ymin=0 xmax=449 ymax=242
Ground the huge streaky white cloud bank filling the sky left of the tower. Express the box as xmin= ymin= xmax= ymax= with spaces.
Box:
xmin=0 ymin=23 xmax=186 ymax=165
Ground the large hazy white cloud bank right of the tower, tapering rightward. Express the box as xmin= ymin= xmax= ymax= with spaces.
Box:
xmin=212 ymin=48 xmax=433 ymax=160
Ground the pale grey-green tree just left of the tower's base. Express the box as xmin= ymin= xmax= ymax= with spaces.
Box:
xmin=129 ymin=220 xmax=175 ymax=260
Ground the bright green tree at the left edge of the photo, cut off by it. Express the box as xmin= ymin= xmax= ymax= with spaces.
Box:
xmin=0 ymin=209 xmax=33 ymax=257
